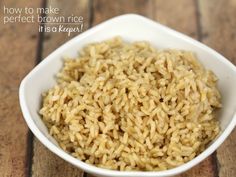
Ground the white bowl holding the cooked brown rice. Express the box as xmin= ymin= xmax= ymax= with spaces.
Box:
xmin=19 ymin=14 xmax=236 ymax=177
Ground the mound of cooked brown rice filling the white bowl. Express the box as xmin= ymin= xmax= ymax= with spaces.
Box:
xmin=39 ymin=37 xmax=221 ymax=171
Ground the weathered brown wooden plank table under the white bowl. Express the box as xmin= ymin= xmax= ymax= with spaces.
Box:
xmin=0 ymin=0 xmax=236 ymax=177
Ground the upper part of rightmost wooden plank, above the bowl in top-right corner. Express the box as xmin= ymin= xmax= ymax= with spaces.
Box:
xmin=199 ymin=0 xmax=236 ymax=64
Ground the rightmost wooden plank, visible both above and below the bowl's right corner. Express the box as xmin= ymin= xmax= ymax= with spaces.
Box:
xmin=199 ymin=0 xmax=236 ymax=177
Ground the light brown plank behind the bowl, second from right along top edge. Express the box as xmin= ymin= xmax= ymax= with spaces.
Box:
xmin=151 ymin=0 xmax=198 ymax=39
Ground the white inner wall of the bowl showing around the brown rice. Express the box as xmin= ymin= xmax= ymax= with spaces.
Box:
xmin=22 ymin=15 xmax=236 ymax=176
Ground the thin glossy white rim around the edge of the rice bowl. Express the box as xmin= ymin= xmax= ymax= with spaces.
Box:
xmin=19 ymin=14 xmax=236 ymax=177
